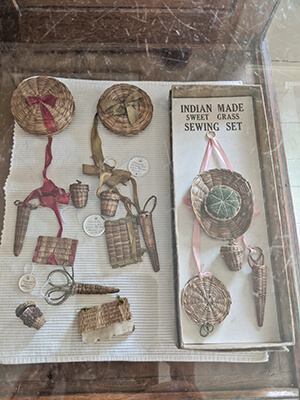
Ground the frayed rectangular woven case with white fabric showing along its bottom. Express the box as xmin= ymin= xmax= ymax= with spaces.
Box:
xmin=78 ymin=298 xmax=134 ymax=343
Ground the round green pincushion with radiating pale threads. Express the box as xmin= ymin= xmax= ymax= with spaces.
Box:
xmin=205 ymin=186 xmax=241 ymax=219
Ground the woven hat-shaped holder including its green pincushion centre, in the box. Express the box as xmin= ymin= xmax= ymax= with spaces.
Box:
xmin=191 ymin=169 xmax=254 ymax=240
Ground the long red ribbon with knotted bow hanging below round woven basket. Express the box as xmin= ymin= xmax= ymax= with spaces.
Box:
xmin=24 ymin=137 xmax=71 ymax=237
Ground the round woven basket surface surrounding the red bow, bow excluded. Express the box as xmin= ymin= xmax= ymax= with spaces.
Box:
xmin=11 ymin=76 xmax=75 ymax=136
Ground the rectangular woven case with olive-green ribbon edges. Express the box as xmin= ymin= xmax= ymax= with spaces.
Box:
xmin=105 ymin=217 xmax=142 ymax=268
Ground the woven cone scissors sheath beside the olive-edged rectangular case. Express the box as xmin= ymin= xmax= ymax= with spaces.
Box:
xmin=138 ymin=212 xmax=160 ymax=272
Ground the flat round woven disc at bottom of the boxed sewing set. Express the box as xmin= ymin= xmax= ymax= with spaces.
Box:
xmin=181 ymin=275 xmax=231 ymax=325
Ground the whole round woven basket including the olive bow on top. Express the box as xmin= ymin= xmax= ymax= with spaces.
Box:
xmin=97 ymin=83 xmax=153 ymax=136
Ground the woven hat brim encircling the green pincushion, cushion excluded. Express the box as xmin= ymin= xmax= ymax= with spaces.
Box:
xmin=191 ymin=169 xmax=254 ymax=240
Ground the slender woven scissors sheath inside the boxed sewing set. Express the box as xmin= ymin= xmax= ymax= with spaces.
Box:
xmin=252 ymin=265 xmax=267 ymax=327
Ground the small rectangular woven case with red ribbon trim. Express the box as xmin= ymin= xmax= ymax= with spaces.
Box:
xmin=32 ymin=236 xmax=78 ymax=265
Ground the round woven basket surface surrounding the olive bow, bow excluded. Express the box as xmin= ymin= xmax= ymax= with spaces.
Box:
xmin=97 ymin=83 xmax=153 ymax=136
